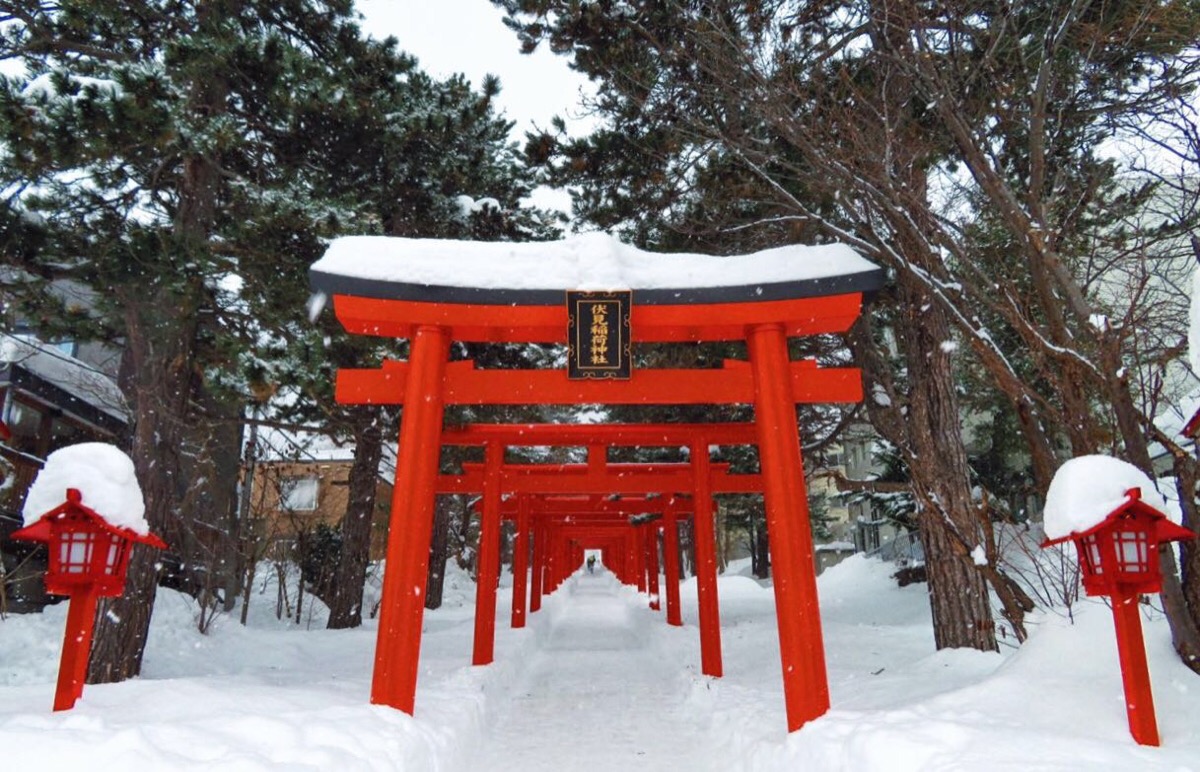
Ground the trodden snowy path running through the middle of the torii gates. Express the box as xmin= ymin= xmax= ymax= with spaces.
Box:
xmin=473 ymin=574 xmax=712 ymax=772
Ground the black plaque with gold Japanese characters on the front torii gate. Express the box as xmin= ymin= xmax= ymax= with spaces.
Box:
xmin=566 ymin=289 xmax=634 ymax=381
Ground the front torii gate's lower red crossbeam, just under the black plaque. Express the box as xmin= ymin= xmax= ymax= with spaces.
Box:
xmin=336 ymin=359 xmax=863 ymax=408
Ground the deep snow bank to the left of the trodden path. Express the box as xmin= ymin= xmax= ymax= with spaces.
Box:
xmin=0 ymin=561 xmax=501 ymax=772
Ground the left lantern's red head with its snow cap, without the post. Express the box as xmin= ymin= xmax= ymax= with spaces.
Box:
xmin=12 ymin=443 xmax=167 ymax=597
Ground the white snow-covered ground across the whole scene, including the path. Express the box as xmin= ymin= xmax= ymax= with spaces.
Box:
xmin=0 ymin=557 xmax=1200 ymax=772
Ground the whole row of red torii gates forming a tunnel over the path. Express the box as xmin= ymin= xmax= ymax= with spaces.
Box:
xmin=310 ymin=235 xmax=883 ymax=731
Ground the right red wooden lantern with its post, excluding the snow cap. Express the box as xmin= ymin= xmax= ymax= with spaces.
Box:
xmin=1042 ymin=487 xmax=1195 ymax=746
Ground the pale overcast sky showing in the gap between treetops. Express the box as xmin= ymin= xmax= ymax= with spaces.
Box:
xmin=356 ymin=0 xmax=600 ymax=137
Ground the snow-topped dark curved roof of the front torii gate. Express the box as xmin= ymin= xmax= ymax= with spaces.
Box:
xmin=310 ymin=233 xmax=884 ymax=305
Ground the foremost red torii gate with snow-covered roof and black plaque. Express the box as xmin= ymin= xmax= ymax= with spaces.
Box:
xmin=310 ymin=234 xmax=883 ymax=731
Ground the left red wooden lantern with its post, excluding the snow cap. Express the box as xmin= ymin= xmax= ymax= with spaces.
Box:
xmin=12 ymin=487 xmax=167 ymax=711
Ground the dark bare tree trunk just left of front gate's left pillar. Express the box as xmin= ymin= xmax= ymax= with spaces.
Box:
xmin=328 ymin=407 xmax=383 ymax=629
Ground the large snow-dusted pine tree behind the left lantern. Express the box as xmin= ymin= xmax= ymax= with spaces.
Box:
xmin=0 ymin=0 xmax=561 ymax=681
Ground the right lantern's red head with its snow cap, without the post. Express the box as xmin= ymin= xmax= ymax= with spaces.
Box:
xmin=1042 ymin=456 xmax=1194 ymax=596
